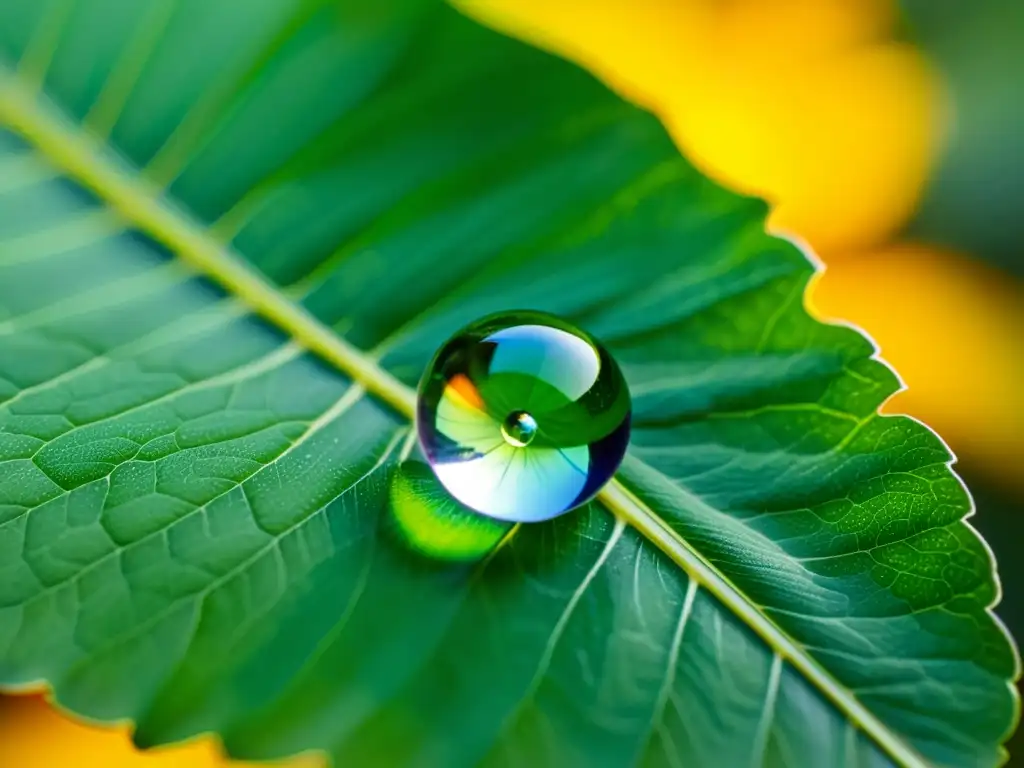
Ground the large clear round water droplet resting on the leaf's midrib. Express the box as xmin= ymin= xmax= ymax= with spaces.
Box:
xmin=417 ymin=311 xmax=631 ymax=522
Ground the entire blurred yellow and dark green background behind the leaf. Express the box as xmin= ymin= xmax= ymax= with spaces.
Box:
xmin=0 ymin=0 xmax=1024 ymax=768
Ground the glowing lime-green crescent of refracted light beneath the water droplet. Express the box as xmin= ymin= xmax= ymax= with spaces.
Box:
xmin=389 ymin=461 xmax=514 ymax=562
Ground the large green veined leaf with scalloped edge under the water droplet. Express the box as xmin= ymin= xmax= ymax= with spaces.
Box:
xmin=0 ymin=0 xmax=1017 ymax=768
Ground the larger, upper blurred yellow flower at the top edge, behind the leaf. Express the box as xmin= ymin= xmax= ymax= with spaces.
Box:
xmin=458 ymin=0 xmax=938 ymax=252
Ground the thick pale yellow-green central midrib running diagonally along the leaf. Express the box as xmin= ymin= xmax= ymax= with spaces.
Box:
xmin=0 ymin=66 xmax=927 ymax=767
